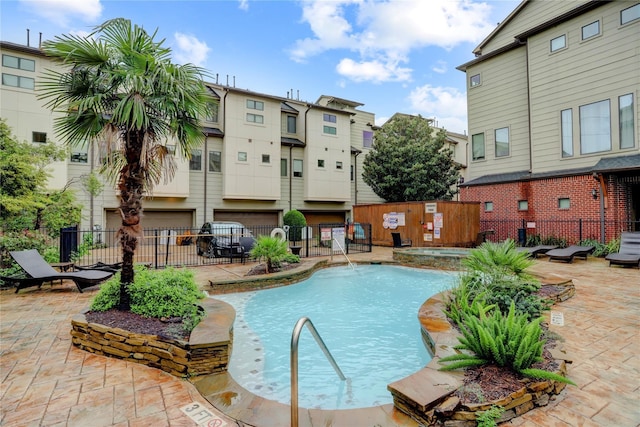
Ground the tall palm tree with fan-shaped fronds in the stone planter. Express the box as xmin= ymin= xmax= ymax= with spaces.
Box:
xmin=38 ymin=18 xmax=214 ymax=310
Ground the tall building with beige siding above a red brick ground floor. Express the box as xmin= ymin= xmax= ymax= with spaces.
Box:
xmin=458 ymin=0 xmax=640 ymax=241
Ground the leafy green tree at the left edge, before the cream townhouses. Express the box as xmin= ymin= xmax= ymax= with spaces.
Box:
xmin=0 ymin=120 xmax=81 ymax=236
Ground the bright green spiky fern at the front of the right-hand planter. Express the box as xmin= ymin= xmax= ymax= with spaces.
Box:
xmin=440 ymin=304 xmax=574 ymax=384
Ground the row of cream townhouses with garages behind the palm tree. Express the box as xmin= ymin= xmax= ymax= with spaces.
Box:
xmin=0 ymin=42 xmax=382 ymax=234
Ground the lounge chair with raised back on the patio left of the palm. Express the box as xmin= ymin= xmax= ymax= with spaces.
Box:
xmin=2 ymin=249 xmax=113 ymax=293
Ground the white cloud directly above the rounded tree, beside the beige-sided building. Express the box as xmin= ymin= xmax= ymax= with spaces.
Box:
xmin=409 ymin=84 xmax=467 ymax=133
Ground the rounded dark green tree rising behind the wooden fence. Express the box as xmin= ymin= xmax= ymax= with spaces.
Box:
xmin=362 ymin=115 xmax=459 ymax=202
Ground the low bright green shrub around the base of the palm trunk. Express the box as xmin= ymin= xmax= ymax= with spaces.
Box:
xmin=91 ymin=267 xmax=204 ymax=332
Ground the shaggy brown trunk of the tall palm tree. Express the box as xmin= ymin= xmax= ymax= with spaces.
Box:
xmin=118 ymin=131 xmax=145 ymax=311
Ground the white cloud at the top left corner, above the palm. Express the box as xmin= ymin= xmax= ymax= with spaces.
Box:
xmin=20 ymin=0 xmax=102 ymax=28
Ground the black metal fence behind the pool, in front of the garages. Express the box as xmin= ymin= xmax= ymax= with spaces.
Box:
xmin=59 ymin=224 xmax=372 ymax=268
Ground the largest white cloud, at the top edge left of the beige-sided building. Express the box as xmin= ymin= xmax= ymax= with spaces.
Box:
xmin=290 ymin=0 xmax=494 ymax=81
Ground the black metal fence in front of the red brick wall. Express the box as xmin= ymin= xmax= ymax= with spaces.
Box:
xmin=480 ymin=218 xmax=640 ymax=246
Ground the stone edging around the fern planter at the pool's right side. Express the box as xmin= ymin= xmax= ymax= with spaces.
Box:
xmin=387 ymin=281 xmax=575 ymax=427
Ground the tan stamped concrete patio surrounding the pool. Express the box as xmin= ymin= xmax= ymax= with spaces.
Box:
xmin=0 ymin=248 xmax=640 ymax=427
